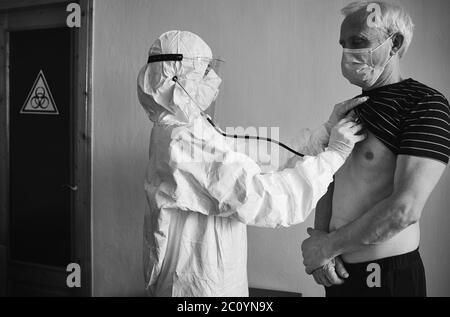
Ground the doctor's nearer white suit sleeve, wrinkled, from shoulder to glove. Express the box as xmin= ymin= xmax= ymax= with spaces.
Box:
xmin=169 ymin=123 xmax=344 ymax=228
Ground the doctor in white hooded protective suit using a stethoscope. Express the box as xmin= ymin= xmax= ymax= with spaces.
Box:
xmin=138 ymin=31 xmax=365 ymax=296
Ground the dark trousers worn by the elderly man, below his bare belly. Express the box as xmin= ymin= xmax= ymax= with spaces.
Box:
xmin=325 ymin=249 xmax=427 ymax=297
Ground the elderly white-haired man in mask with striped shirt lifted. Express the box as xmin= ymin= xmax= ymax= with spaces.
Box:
xmin=302 ymin=2 xmax=450 ymax=297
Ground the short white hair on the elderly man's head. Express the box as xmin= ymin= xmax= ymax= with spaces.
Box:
xmin=342 ymin=1 xmax=414 ymax=57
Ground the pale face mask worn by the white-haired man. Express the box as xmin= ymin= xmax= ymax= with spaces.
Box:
xmin=341 ymin=34 xmax=395 ymax=89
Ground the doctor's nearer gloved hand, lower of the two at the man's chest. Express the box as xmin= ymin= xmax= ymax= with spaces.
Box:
xmin=328 ymin=116 xmax=367 ymax=160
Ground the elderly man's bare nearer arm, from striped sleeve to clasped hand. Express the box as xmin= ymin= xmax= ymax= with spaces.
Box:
xmin=302 ymin=155 xmax=446 ymax=273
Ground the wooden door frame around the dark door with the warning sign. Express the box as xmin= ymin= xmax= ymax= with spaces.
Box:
xmin=0 ymin=0 xmax=93 ymax=296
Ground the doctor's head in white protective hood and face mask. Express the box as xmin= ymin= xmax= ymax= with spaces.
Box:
xmin=137 ymin=31 xmax=222 ymax=125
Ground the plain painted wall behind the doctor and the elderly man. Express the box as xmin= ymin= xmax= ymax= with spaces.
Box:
xmin=93 ymin=0 xmax=450 ymax=296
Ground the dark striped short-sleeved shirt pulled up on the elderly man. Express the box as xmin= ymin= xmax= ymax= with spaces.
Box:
xmin=356 ymin=79 xmax=450 ymax=164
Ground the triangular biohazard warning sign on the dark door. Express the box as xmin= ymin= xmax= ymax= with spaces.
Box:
xmin=20 ymin=70 xmax=59 ymax=114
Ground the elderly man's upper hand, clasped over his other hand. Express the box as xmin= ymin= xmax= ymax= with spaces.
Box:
xmin=302 ymin=228 xmax=334 ymax=274
